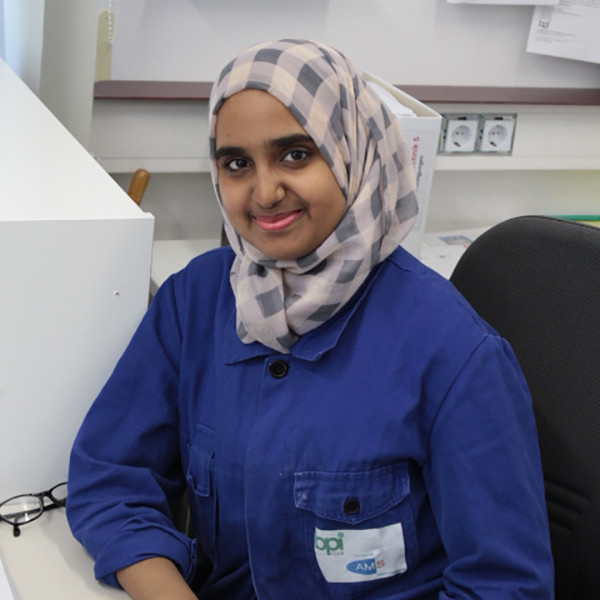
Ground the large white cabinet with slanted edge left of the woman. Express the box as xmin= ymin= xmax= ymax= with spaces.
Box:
xmin=0 ymin=60 xmax=154 ymax=499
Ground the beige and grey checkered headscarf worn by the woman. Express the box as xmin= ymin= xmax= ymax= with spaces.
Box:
xmin=209 ymin=40 xmax=417 ymax=353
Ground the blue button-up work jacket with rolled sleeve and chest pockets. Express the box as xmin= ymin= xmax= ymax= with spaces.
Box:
xmin=67 ymin=249 xmax=553 ymax=600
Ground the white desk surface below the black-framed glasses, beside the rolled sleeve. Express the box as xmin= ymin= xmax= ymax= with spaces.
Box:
xmin=0 ymin=509 xmax=124 ymax=600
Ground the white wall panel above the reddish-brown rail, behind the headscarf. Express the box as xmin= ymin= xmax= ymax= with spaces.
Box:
xmin=112 ymin=0 xmax=600 ymax=87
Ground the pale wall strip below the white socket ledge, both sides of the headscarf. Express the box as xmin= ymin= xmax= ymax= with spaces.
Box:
xmin=114 ymin=170 xmax=600 ymax=240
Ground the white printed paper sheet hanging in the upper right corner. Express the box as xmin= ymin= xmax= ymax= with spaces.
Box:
xmin=527 ymin=0 xmax=600 ymax=63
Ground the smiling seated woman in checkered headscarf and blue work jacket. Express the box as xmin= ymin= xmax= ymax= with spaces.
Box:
xmin=67 ymin=40 xmax=553 ymax=600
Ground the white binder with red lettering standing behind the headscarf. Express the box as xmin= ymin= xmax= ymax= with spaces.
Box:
xmin=362 ymin=71 xmax=442 ymax=257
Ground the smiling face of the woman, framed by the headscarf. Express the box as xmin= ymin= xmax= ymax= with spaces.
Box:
xmin=216 ymin=90 xmax=346 ymax=260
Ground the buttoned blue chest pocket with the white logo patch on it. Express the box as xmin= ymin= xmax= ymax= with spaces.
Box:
xmin=294 ymin=462 xmax=418 ymax=598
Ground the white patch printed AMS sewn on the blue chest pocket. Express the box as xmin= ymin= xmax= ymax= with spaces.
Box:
xmin=315 ymin=523 xmax=406 ymax=583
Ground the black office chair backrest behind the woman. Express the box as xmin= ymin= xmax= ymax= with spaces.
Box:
xmin=451 ymin=216 xmax=600 ymax=600
